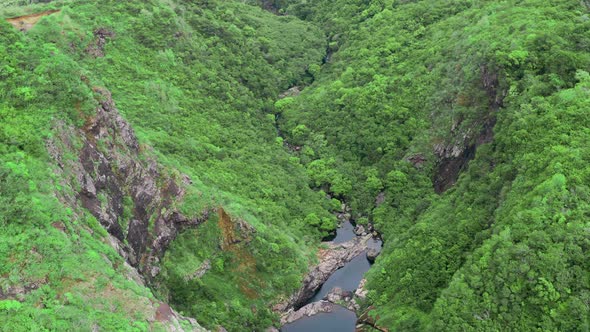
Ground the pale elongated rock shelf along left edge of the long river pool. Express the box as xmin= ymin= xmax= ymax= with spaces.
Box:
xmin=273 ymin=235 xmax=371 ymax=312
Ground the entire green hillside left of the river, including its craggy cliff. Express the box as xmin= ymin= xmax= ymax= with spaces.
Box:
xmin=0 ymin=1 xmax=332 ymax=330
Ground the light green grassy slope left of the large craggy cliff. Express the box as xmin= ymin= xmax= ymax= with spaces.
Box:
xmin=0 ymin=9 xmax=208 ymax=331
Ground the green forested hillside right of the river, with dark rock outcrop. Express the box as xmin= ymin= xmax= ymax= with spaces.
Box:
xmin=281 ymin=0 xmax=590 ymax=331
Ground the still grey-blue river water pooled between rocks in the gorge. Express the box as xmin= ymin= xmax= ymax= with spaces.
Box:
xmin=281 ymin=222 xmax=381 ymax=332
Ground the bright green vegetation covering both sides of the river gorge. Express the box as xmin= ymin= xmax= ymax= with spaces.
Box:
xmin=0 ymin=0 xmax=590 ymax=331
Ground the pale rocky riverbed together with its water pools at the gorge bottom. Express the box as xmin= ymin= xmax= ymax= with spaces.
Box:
xmin=273 ymin=221 xmax=381 ymax=331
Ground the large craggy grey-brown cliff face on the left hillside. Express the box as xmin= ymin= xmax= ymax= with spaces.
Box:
xmin=47 ymin=88 xmax=209 ymax=278
